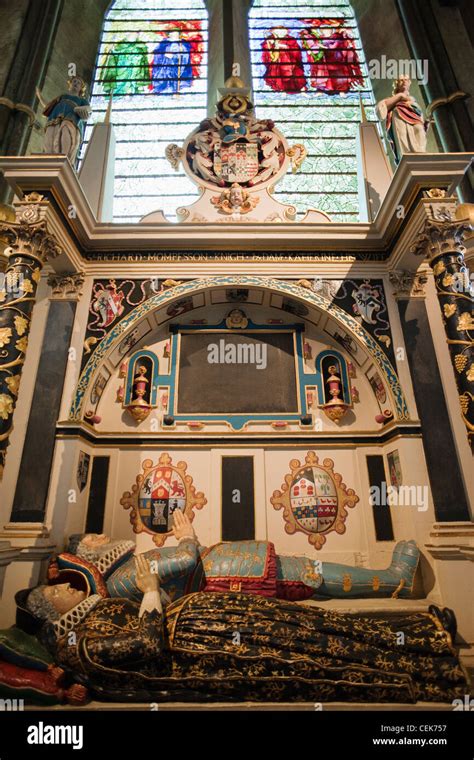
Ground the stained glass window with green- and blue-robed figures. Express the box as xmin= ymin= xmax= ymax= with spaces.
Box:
xmin=81 ymin=0 xmax=208 ymax=223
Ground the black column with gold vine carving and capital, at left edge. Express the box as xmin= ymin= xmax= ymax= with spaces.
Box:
xmin=0 ymin=204 xmax=60 ymax=480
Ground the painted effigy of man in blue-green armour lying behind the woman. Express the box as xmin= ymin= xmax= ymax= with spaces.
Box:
xmin=50 ymin=510 xmax=420 ymax=601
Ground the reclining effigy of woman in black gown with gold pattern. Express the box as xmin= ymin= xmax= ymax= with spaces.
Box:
xmin=17 ymin=555 xmax=468 ymax=702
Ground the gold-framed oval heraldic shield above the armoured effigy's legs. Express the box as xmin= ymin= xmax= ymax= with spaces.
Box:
xmin=270 ymin=451 xmax=359 ymax=549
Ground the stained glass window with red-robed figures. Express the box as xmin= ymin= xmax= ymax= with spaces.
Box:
xmin=250 ymin=0 xmax=377 ymax=222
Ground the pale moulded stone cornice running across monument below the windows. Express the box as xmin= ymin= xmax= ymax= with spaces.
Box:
xmin=0 ymin=153 xmax=472 ymax=269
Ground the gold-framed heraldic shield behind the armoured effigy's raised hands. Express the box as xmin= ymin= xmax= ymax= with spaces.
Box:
xmin=120 ymin=453 xmax=207 ymax=546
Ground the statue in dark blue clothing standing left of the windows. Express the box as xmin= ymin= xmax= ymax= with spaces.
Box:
xmin=36 ymin=76 xmax=91 ymax=166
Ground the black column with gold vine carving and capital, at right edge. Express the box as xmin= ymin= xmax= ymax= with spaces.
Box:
xmin=412 ymin=208 xmax=474 ymax=446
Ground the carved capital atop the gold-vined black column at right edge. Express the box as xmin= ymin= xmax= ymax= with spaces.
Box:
xmin=410 ymin=206 xmax=472 ymax=260
